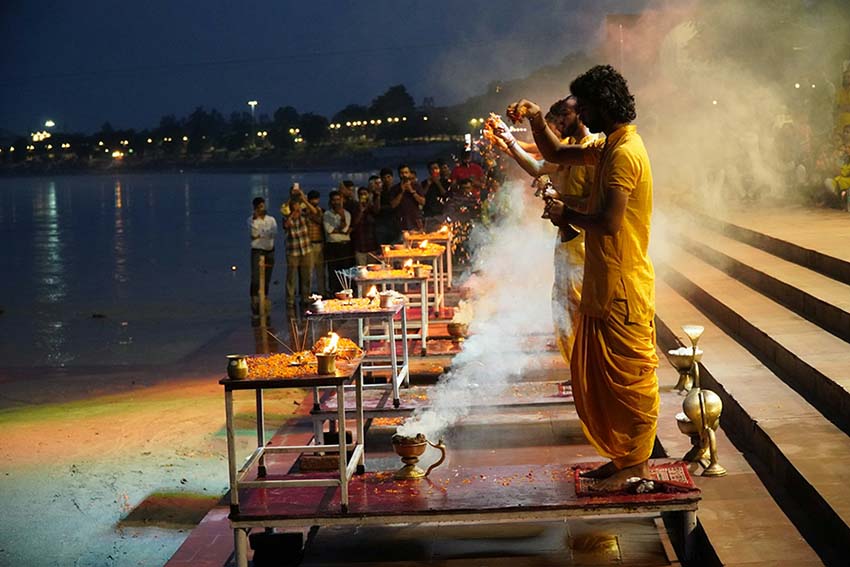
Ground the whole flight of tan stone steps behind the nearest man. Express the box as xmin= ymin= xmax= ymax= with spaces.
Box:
xmin=656 ymin=206 xmax=850 ymax=565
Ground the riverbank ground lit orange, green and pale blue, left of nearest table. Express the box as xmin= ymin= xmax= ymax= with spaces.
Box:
xmin=0 ymin=375 xmax=304 ymax=566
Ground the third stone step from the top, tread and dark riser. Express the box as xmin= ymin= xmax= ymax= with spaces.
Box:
xmin=661 ymin=246 xmax=850 ymax=434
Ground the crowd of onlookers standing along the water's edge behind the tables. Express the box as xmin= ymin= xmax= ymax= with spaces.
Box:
xmin=249 ymin=151 xmax=490 ymax=314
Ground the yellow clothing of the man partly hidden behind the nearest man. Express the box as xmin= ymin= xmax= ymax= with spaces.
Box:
xmin=552 ymin=134 xmax=601 ymax=364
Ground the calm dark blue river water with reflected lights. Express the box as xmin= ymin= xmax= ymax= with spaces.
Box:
xmin=0 ymin=172 xmax=369 ymax=367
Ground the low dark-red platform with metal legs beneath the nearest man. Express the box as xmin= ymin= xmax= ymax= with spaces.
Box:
xmin=230 ymin=464 xmax=700 ymax=567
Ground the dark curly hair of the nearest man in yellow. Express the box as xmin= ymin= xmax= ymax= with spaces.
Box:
xmin=570 ymin=65 xmax=637 ymax=122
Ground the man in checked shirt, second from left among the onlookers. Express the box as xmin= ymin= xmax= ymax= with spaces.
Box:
xmin=283 ymin=184 xmax=313 ymax=312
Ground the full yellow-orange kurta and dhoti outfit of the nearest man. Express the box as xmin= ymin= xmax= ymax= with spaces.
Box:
xmin=570 ymin=125 xmax=659 ymax=469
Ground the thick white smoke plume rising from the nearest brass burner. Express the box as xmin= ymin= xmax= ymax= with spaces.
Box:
xmin=398 ymin=182 xmax=568 ymax=440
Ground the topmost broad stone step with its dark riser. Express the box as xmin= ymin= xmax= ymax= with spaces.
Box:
xmin=676 ymin=207 xmax=850 ymax=284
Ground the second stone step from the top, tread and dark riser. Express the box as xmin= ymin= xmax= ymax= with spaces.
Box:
xmin=676 ymin=223 xmax=850 ymax=342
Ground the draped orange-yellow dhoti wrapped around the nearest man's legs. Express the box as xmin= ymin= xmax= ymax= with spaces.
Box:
xmin=570 ymin=300 xmax=659 ymax=469
